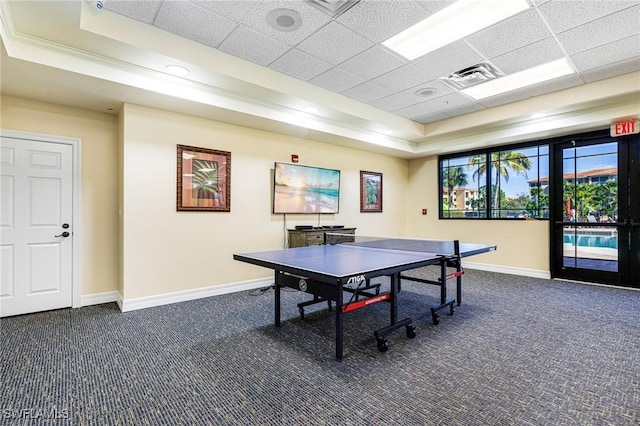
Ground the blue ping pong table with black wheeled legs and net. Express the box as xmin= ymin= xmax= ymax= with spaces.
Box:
xmin=233 ymin=233 xmax=496 ymax=361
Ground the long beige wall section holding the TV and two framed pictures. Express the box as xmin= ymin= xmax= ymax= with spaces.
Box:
xmin=121 ymin=105 xmax=408 ymax=300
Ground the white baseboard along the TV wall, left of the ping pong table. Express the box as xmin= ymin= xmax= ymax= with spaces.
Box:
xmin=115 ymin=277 xmax=273 ymax=312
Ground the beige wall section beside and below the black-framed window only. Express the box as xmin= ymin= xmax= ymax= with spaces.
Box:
xmin=407 ymin=157 xmax=549 ymax=274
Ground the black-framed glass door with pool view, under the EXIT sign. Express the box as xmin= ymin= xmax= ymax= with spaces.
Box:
xmin=551 ymin=137 xmax=640 ymax=287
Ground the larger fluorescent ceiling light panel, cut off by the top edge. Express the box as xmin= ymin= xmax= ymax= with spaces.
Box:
xmin=382 ymin=0 xmax=529 ymax=61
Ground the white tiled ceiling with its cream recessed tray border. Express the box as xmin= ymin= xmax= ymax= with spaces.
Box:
xmin=0 ymin=0 xmax=640 ymax=158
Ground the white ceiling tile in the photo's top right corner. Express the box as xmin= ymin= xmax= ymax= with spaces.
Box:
xmin=538 ymin=0 xmax=638 ymax=33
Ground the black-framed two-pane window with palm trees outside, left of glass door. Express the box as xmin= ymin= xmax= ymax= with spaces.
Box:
xmin=440 ymin=145 xmax=549 ymax=219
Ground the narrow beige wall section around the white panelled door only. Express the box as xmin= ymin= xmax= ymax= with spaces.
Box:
xmin=0 ymin=96 xmax=118 ymax=295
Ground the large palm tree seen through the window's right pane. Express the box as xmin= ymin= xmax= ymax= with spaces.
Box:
xmin=469 ymin=151 xmax=531 ymax=213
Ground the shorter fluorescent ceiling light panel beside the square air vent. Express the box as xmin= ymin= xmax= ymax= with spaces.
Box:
xmin=460 ymin=58 xmax=574 ymax=100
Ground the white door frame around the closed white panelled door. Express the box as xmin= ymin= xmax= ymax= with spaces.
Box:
xmin=0 ymin=128 xmax=82 ymax=308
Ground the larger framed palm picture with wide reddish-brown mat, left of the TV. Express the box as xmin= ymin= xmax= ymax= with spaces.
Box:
xmin=176 ymin=145 xmax=231 ymax=212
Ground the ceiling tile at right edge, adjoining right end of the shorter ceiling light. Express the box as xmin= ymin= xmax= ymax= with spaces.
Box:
xmin=571 ymin=35 xmax=640 ymax=72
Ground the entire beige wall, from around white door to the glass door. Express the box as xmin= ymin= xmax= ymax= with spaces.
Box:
xmin=1 ymin=96 xmax=549 ymax=301
